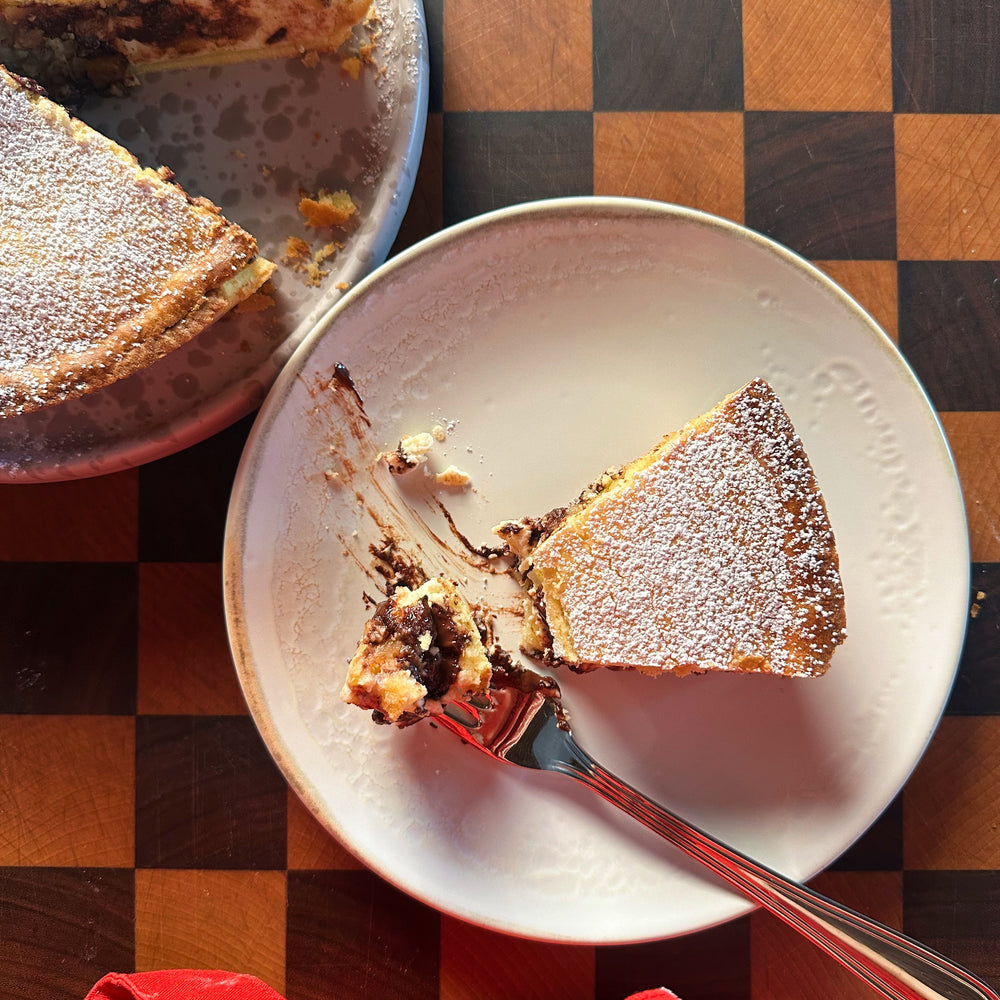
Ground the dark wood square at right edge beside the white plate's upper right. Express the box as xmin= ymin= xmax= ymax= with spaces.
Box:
xmin=899 ymin=260 xmax=1000 ymax=410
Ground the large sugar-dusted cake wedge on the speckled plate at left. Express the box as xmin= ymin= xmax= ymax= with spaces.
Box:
xmin=0 ymin=67 xmax=274 ymax=417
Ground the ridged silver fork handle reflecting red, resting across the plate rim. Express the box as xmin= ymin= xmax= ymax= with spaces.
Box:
xmin=552 ymin=738 xmax=1000 ymax=1000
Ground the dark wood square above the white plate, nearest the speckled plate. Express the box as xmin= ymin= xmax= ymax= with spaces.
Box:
xmin=442 ymin=111 xmax=594 ymax=225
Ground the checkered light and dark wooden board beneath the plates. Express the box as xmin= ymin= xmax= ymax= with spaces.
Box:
xmin=0 ymin=0 xmax=1000 ymax=1000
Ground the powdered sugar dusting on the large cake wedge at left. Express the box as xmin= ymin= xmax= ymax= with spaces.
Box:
xmin=0 ymin=75 xmax=229 ymax=408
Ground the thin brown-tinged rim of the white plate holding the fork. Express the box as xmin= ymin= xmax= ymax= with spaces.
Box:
xmin=222 ymin=195 xmax=971 ymax=946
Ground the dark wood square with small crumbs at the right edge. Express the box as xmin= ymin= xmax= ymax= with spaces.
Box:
xmin=947 ymin=563 xmax=1000 ymax=715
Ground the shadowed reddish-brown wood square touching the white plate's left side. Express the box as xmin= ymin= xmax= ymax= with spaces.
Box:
xmin=138 ymin=563 xmax=247 ymax=715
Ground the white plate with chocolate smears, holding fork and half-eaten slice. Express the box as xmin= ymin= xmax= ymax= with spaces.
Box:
xmin=225 ymin=199 xmax=969 ymax=943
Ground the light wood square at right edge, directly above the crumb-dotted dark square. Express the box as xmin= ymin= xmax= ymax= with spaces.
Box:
xmin=940 ymin=411 xmax=1000 ymax=562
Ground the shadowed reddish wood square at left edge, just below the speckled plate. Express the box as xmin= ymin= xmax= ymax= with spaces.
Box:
xmin=0 ymin=470 xmax=139 ymax=562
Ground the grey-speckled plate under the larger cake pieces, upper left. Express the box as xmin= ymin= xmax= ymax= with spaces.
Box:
xmin=0 ymin=0 xmax=428 ymax=482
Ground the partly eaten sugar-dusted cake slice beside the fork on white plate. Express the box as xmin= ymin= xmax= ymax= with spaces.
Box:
xmin=495 ymin=379 xmax=846 ymax=676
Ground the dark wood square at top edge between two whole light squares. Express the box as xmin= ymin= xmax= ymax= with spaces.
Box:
xmin=593 ymin=0 xmax=743 ymax=111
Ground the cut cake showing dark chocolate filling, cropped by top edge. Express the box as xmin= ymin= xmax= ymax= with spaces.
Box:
xmin=0 ymin=0 xmax=371 ymax=96
